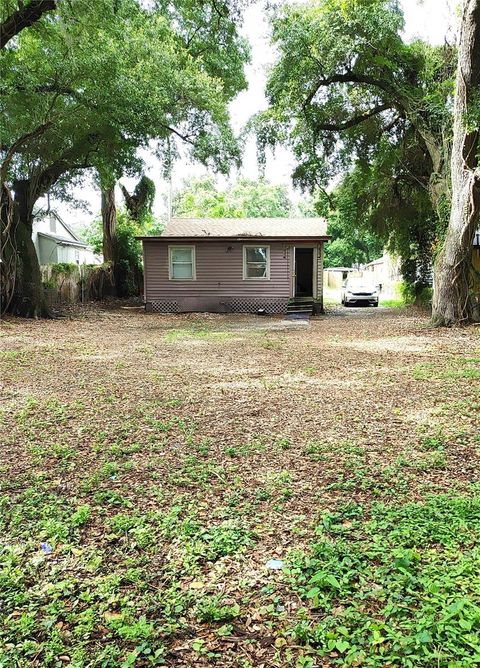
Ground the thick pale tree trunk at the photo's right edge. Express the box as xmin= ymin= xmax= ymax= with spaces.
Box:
xmin=432 ymin=0 xmax=480 ymax=326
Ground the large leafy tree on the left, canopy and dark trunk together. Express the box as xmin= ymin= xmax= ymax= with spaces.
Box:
xmin=0 ymin=0 xmax=248 ymax=316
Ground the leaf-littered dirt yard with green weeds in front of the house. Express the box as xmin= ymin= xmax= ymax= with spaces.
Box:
xmin=0 ymin=306 xmax=480 ymax=668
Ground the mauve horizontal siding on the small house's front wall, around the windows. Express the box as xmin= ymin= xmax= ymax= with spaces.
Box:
xmin=143 ymin=239 xmax=291 ymax=302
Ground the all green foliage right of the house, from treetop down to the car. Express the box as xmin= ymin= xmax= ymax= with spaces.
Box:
xmin=252 ymin=0 xmax=456 ymax=292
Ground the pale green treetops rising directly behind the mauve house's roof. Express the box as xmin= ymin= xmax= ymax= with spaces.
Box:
xmin=173 ymin=177 xmax=292 ymax=218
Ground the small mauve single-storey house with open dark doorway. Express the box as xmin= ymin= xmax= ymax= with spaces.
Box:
xmin=139 ymin=218 xmax=329 ymax=313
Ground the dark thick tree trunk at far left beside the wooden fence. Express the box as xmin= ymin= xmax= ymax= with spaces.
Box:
xmin=2 ymin=179 xmax=51 ymax=318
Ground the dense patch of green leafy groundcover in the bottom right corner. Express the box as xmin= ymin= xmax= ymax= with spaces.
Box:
xmin=290 ymin=495 xmax=480 ymax=668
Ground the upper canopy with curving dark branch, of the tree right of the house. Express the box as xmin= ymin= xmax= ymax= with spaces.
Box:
xmin=256 ymin=0 xmax=455 ymax=193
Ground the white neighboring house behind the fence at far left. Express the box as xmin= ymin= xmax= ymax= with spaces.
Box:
xmin=32 ymin=211 xmax=103 ymax=265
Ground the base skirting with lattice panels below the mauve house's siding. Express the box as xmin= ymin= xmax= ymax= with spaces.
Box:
xmin=145 ymin=297 xmax=288 ymax=314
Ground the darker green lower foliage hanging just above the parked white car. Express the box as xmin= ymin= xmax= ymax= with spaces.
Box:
xmin=327 ymin=137 xmax=439 ymax=294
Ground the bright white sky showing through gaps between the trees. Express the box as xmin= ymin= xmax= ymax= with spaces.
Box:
xmin=51 ymin=0 xmax=456 ymax=227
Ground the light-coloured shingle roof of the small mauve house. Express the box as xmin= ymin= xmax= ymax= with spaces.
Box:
xmin=162 ymin=218 xmax=327 ymax=238
